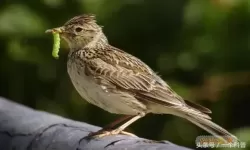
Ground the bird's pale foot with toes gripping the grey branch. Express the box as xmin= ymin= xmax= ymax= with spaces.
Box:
xmin=88 ymin=129 xmax=137 ymax=138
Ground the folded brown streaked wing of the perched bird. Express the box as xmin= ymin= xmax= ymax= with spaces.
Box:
xmin=79 ymin=47 xmax=185 ymax=107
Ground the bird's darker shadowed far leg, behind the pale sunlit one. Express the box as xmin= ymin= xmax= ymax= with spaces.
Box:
xmin=89 ymin=116 xmax=134 ymax=136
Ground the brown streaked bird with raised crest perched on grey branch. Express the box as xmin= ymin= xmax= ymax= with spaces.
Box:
xmin=46 ymin=14 xmax=237 ymax=142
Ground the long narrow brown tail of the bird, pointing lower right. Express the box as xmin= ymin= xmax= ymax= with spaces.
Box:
xmin=176 ymin=112 xmax=239 ymax=142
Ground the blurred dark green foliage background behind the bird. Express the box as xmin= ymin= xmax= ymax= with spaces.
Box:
xmin=0 ymin=0 xmax=250 ymax=148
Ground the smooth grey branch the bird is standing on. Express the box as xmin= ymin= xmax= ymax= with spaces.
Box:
xmin=0 ymin=98 xmax=191 ymax=150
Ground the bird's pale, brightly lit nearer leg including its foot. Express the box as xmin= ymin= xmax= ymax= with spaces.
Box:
xmin=92 ymin=114 xmax=144 ymax=138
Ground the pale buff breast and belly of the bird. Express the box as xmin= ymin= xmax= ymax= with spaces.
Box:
xmin=67 ymin=60 xmax=145 ymax=115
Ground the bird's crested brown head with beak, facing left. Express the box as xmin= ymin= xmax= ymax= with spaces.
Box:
xmin=46 ymin=14 xmax=107 ymax=49
